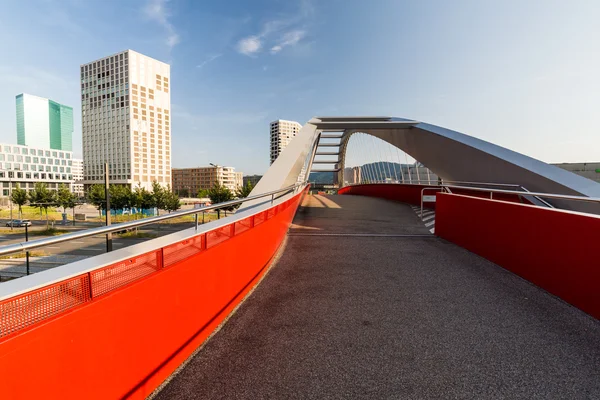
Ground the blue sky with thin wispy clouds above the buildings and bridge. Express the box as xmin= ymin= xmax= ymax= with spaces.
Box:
xmin=0 ymin=0 xmax=600 ymax=173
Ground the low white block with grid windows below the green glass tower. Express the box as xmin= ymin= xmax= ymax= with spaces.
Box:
xmin=0 ymin=144 xmax=73 ymax=197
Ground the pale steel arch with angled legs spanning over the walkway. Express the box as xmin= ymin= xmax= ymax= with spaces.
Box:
xmin=245 ymin=117 xmax=600 ymax=213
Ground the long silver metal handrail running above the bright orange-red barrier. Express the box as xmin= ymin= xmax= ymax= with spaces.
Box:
xmin=0 ymin=182 xmax=306 ymax=256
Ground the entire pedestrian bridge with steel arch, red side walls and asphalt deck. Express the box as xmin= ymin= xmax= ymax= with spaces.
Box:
xmin=0 ymin=117 xmax=600 ymax=399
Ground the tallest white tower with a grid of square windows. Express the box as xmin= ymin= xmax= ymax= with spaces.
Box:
xmin=81 ymin=50 xmax=171 ymax=189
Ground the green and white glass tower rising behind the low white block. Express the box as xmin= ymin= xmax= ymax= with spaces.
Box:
xmin=16 ymin=93 xmax=73 ymax=151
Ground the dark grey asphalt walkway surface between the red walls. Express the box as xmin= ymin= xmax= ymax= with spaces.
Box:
xmin=158 ymin=196 xmax=600 ymax=399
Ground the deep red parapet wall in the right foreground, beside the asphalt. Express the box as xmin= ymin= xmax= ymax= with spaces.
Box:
xmin=435 ymin=193 xmax=600 ymax=319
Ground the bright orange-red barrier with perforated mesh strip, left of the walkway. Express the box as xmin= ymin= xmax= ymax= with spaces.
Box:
xmin=0 ymin=188 xmax=305 ymax=400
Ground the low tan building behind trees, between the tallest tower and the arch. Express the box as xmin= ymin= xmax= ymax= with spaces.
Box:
xmin=173 ymin=166 xmax=243 ymax=197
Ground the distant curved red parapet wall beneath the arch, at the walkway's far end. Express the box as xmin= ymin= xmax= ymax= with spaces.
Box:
xmin=338 ymin=183 xmax=439 ymax=208
